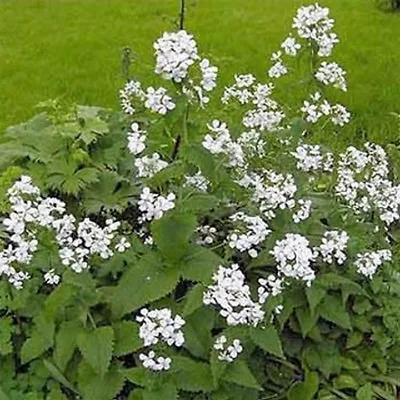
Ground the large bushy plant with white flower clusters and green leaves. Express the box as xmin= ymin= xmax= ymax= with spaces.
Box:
xmin=0 ymin=5 xmax=400 ymax=400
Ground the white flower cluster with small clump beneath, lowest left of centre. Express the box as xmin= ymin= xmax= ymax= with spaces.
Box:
xmin=136 ymin=308 xmax=185 ymax=371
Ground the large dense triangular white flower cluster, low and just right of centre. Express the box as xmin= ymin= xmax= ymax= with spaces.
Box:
xmin=203 ymin=264 xmax=264 ymax=326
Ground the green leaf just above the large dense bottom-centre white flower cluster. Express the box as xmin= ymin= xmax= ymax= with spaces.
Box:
xmin=180 ymin=244 xmax=222 ymax=285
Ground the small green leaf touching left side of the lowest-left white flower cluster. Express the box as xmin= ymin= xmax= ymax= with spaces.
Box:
xmin=114 ymin=321 xmax=143 ymax=357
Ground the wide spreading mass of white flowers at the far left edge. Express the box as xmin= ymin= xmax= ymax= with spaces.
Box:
xmin=0 ymin=176 xmax=130 ymax=289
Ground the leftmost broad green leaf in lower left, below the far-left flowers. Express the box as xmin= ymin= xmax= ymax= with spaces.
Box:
xmin=21 ymin=315 xmax=55 ymax=364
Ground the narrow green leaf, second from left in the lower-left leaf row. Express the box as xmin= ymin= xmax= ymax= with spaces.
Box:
xmin=53 ymin=321 xmax=82 ymax=371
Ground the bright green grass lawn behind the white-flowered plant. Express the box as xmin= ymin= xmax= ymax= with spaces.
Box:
xmin=0 ymin=0 xmax=400 ymax=142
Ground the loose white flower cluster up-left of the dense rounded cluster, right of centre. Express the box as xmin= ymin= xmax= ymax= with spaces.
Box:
xmin=228 ymin=212 xmax=271 ymax=258
